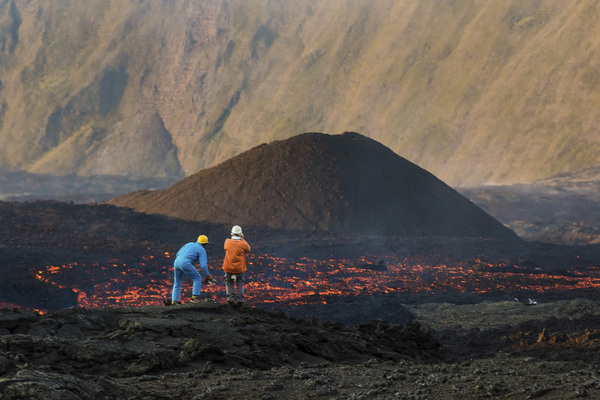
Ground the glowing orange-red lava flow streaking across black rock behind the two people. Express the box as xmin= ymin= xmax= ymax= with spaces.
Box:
xmin=28 ymin=253 xmax=600 ymax=308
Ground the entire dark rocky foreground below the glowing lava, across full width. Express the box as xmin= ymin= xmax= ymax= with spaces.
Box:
xmin=0 ymin=299 xmax=600 ymax=400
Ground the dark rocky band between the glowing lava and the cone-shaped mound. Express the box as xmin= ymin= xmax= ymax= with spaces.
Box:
xmin=0 ymin=201 xmax=564 ymax=310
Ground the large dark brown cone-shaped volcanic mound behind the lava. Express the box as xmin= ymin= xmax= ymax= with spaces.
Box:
xmin=109 ymin=132 xmax=517 ymax=239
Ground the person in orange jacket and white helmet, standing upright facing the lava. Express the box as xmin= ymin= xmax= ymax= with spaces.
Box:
xmin=223 ymin=225 xmax=250 ymax=307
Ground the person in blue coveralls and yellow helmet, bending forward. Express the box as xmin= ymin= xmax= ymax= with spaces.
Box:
xmin=165 ymin=235 xmax=216 ymax=306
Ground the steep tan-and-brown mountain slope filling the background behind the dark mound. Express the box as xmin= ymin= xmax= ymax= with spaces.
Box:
xmin=0 ymin=0 xmax=600 ymax=186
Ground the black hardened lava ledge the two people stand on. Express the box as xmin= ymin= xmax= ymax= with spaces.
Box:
xmin=0 ymin=303 xmax=440 ymax=400
